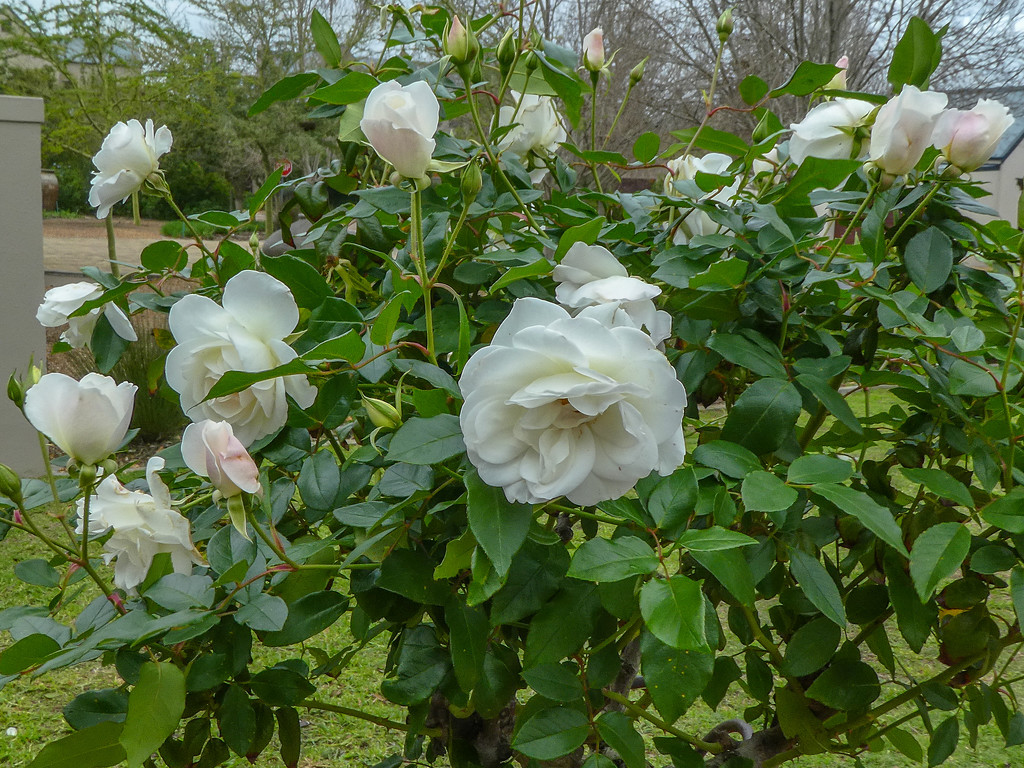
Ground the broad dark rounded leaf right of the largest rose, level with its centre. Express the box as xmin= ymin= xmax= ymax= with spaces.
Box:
xmin=722 ymin=379 xmax=802 ymax=455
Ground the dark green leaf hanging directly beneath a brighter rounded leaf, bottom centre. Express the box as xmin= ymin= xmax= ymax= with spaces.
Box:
xmin=640 ymin=632 xmax=715 ymax=723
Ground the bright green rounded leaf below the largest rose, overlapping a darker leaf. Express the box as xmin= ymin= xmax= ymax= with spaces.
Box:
xmin=640 ymin=575 xmax=708 ymax=650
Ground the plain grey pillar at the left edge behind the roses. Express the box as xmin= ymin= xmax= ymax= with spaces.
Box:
xmin=0 ymin=96 xmax=46 ymax=476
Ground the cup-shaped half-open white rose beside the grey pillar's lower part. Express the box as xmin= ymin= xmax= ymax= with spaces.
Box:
xmin=25 ymin=374 xmax=138 ymax=464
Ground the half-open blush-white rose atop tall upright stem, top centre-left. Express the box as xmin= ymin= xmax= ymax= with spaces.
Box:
xmin=359 ymin=80 xmax=440 ymax=178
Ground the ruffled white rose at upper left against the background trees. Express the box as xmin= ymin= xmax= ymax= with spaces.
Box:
xmin=89 ymin=120 xmax=172 ymax=219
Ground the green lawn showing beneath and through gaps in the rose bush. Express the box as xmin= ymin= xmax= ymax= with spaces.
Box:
xmin=6 ymin=392 xmax=1024 ymax=768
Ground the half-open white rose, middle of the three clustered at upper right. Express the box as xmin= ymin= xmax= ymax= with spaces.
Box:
xmin=868 ymin=85 xmax=947 ymax=176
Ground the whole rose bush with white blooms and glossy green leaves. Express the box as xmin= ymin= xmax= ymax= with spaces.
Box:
xmin=0 ymin=6 xmax=1024 ymax=768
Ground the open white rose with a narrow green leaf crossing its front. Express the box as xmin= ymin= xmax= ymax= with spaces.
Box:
xmin=165 ymin=270 xmax=316 ymax=445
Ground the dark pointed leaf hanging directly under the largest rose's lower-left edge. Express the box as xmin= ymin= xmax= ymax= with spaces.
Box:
xmin=464 ymin=468 xmax=534 ymax=575
